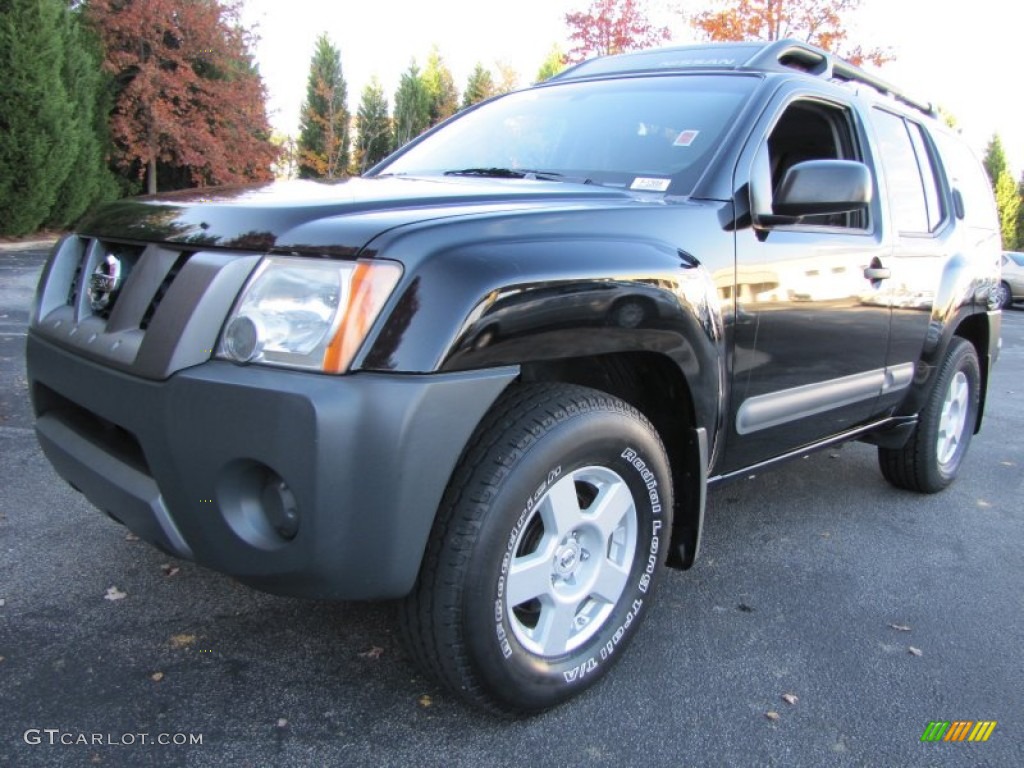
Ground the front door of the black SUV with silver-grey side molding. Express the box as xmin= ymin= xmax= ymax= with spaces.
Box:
xmin=725 ymin=94 xmax=892 ymax=471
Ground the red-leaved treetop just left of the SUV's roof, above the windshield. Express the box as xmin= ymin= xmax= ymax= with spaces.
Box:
xmin=565 ymin=0 xmax=671 ymax=63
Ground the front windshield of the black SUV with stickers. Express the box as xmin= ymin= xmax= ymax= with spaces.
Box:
xmin=377 ymin=75 xmax=757 ymax=195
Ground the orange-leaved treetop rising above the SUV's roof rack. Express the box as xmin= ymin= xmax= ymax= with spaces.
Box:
xmin=692 ymin=0 xmax=893 ymax=66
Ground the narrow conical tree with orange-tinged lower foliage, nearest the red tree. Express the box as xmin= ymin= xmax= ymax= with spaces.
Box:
xmin=298 ymin=33 xmax=349 ymax=178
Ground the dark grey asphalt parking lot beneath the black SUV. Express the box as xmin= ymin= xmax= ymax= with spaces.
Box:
xmin=0 ymin=250 xmax=1024 ymax=767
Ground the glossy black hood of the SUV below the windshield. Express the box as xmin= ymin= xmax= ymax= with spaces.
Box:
xmin=77 ymin=176 xmax=634 ymax=256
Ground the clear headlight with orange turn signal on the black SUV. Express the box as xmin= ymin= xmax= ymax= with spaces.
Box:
xmin=217 ymin=256 xmax=401 ymax=373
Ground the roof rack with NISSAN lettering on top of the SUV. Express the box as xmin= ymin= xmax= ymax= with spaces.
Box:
xmin=551 ymin=39 xmax=938 ymax=117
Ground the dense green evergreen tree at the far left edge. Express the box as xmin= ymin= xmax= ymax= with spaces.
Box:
xmin=0 ymin=0 xmax=80 ymax=234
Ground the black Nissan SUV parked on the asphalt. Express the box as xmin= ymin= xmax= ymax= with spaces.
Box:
xmin=28 ymin=41 xmax=1000 ymax=712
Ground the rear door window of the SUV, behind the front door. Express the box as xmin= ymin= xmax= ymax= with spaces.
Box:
xmin=873 ymin=109 xmax=943 ymax=234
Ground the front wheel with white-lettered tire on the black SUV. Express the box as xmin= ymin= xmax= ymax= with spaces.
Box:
xmin=399 ymin=384 xmax=672 ymax=714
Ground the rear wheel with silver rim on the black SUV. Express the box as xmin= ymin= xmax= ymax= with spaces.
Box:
xmin=879 ymin=338 xmax=981 ymax=494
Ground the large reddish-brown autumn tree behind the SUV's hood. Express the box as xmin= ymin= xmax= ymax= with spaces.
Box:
xmin=88 ymin=0 xmax=279 ymax=194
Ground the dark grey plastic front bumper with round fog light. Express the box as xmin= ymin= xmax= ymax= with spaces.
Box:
xmin=27 ymin=332 xmax=518 ymax=599
